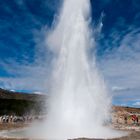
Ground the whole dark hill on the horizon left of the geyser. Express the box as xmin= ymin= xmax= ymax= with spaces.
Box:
xmin=0 ymin=88 xmax=46 ymax=116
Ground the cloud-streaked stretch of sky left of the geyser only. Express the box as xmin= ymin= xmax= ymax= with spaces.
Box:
xmin=0 ymin=0 xmax=58 ymax=92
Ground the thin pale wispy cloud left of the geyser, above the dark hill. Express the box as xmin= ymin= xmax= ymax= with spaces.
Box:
xmin=0 ymin=24 xmax=51 ymax=93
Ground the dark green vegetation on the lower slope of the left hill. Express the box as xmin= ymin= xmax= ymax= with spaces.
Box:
xmin=0 ymin=99 xmax=42 ymax=116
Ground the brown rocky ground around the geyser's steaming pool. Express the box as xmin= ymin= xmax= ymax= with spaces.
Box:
xmin=0 ymin=102 xmax=140 ymax=140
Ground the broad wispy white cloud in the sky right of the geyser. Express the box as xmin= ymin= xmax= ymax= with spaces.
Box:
xmin=100 ymin=24 xmax=140 ymax=105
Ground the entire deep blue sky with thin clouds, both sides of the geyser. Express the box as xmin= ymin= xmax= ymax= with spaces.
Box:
xmin=0 ymin=0 xmax=140 ymax=107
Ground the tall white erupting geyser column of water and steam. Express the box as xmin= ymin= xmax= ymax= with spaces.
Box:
xmin=27 ymin=0 xmax=123 ymax=139
